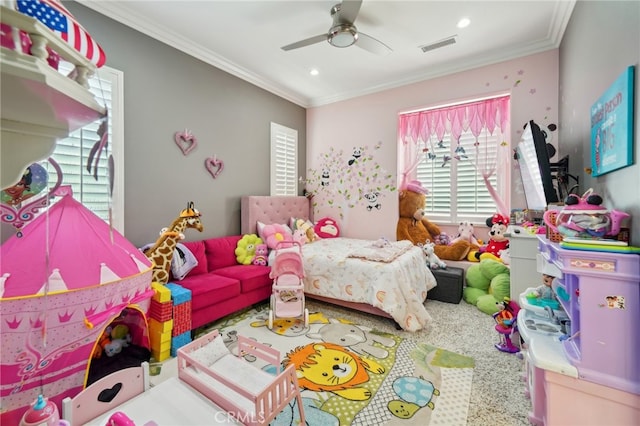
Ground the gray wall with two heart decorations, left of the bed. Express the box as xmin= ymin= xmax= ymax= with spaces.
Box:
xmin=65 ymin=3 xmax=306 ymax=246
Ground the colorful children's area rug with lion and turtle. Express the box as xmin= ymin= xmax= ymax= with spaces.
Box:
xmin=200 ymin=306 xmax=474 ymax=426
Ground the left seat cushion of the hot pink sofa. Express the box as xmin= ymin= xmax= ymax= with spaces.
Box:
xmin=180 ymin=273 xmax=241 ymax=311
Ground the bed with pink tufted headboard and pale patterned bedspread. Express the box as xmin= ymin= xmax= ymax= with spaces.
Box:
xmin=241 ymin=196 xmax=436 ymax=331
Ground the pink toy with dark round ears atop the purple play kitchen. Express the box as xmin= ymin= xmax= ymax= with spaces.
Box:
xmin=544 ymin=188 xmax=629 ymax=238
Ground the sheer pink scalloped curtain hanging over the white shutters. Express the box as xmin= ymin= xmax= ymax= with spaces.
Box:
xmin=398 ymin=96 xmax=510 ymax=215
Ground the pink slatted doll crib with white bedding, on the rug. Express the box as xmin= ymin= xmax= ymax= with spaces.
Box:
xmin=178 ymin=330 xmax=305 ymax=425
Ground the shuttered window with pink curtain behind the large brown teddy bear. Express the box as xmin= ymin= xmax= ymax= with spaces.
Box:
xmin=398 ymin=94 xmax=510 ymax=223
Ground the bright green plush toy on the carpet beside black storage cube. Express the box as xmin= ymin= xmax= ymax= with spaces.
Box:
xmin=462 ymin=259 xmax=511 ymax=315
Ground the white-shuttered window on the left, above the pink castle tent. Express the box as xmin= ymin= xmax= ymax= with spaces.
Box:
xmin=52 ymin=62 xmax=124 ymax=233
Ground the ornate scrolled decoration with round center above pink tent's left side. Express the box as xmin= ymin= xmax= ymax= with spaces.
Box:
xmin=0 ymin=158 xmax=62 ymax=238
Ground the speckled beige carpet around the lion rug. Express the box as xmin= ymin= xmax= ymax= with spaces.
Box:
xmin=307 ymin=299 xmax=530 ymax=426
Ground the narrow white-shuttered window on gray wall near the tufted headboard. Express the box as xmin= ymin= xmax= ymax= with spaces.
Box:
xmin=271 ymin=123 xmax=298 ymax=195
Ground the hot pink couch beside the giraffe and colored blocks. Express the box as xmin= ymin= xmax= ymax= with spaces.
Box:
xmin=173 ymin=235 xmax=273 ymax=329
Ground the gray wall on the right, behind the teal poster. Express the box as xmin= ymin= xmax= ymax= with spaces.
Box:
xmin=558 ymin=0 xmax=640 ymax=246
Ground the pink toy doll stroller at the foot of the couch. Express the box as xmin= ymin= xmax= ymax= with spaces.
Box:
xmin=268 ymin=241 xmax=309 ymax=330
